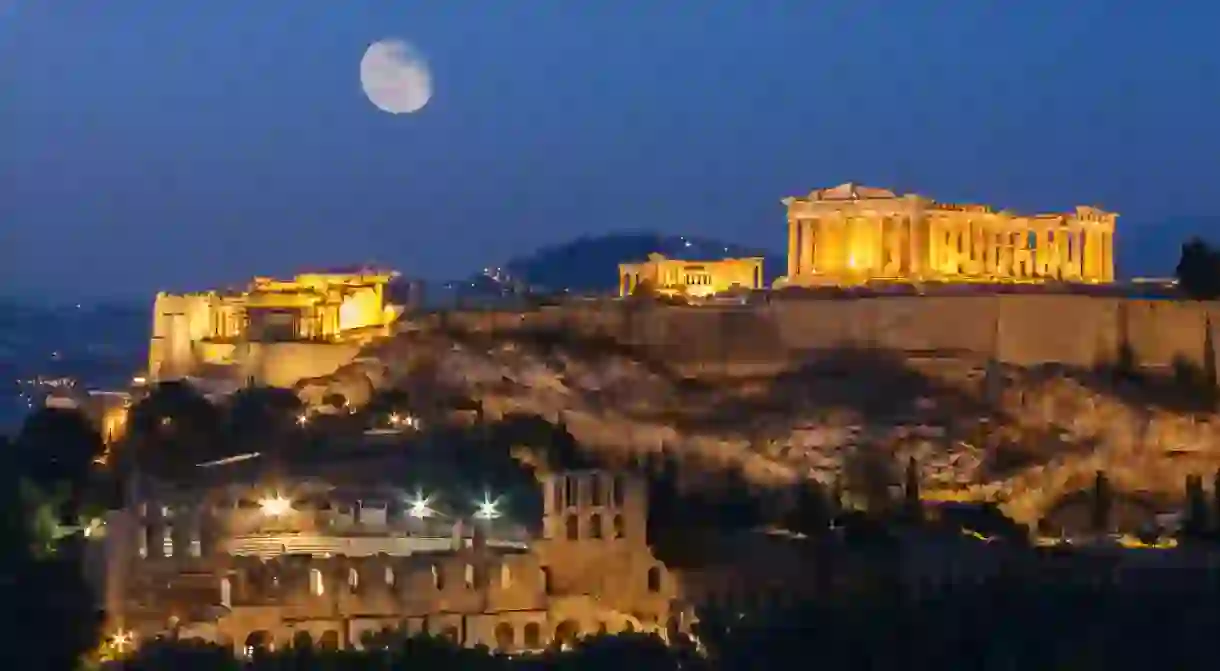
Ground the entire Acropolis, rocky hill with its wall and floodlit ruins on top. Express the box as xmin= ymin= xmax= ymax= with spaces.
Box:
xmin=138 ymin=184 xmax=1220 ymax=521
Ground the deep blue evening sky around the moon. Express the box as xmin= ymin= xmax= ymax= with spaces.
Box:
xmin=0 ymin=0 xmax=1220 ymax=296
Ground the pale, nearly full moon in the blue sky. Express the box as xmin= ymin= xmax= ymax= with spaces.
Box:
xmin=360 ymin=39 xmax=432 ymax=115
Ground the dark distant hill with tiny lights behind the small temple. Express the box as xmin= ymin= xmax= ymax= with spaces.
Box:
xmin=448 ymin=233 xmax=786 ymax=293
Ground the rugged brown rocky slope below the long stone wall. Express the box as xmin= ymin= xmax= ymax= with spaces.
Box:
xmin=305 ymin=331 xmax=1220 ymax=531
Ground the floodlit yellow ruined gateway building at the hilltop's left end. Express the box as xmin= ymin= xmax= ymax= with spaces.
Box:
xmin=146 ymin=268 xmax=404 ymax=386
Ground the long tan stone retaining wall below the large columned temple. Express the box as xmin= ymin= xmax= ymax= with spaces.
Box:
xmin=447 ymin=294 xmax=1220 ymax=375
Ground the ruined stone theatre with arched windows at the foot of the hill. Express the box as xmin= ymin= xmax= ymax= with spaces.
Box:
xmin=97 ymin=471 xmax=810 ymax=653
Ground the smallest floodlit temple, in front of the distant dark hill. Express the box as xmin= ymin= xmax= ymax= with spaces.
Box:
xmin=619 ymin=254 xmax=763 ymax=298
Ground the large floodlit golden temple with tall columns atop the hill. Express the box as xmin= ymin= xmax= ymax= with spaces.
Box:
xmin=776 ymin=182 xmax=1118 ymax=287
